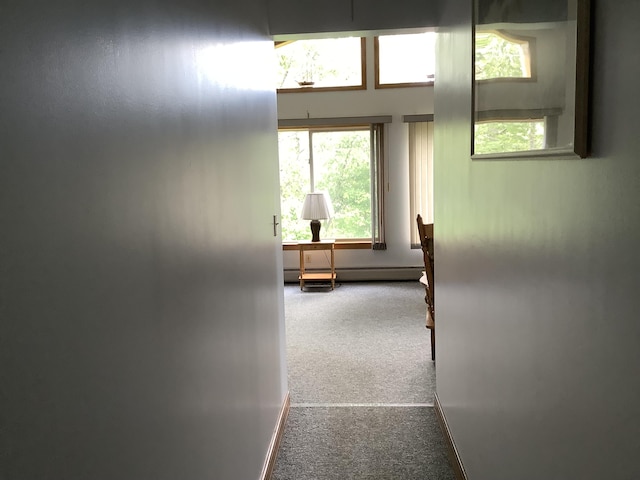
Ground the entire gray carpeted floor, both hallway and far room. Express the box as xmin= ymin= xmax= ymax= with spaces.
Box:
xmin=272 ymin=282 xmax=455 ymax=480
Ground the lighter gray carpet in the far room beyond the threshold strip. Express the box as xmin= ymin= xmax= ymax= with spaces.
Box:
xmin=285 ymin=281 xmax=435 ymax=404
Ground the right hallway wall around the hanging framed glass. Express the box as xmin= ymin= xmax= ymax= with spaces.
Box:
xmin=435 ymin=0 xmax=640 ymax=480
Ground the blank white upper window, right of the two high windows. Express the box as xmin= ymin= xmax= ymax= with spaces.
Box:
xmin=374 ymin=32 xmax=436 ymax=88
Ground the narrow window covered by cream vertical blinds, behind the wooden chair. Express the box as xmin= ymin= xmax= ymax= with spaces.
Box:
xmin=405 ymin=115 xmax=433 ymax=248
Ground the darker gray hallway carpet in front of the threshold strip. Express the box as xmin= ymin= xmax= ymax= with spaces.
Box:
xmin=271 ymin=407 xmax=455 ymax=480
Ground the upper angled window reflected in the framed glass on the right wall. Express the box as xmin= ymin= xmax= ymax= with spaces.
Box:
xmin=475 ymin=31 xmax=535 ymax=80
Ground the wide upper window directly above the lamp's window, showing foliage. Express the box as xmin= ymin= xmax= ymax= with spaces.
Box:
xmin=275 ymin=37 xmax=366 ymax=93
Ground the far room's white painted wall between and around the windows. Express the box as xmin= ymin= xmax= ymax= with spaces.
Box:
xmin=278 ymin=37 xmax=433 ymax=278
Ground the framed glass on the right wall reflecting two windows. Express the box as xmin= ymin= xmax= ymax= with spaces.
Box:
xmin=472 ymin=0 xmax=589 ymax=158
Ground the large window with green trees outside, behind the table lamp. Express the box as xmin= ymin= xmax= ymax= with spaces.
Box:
xmin=278 ymin=125 xmax=384 ymax=248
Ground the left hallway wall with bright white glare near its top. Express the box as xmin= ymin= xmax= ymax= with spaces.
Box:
xmin=0 ymin=0 xmax=287 ymax=480
